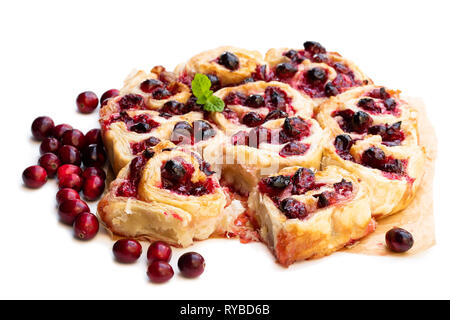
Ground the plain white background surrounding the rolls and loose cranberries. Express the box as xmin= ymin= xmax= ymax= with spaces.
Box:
xmin=0 ymin=0 xmax=450 ymax=299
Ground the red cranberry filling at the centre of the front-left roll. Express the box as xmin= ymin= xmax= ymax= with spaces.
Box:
xmin=161 ymin=158 xmax=215 ymax=196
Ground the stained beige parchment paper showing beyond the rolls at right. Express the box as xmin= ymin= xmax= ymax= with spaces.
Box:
xmin=342 ymin=98 xmax=437 ymax=255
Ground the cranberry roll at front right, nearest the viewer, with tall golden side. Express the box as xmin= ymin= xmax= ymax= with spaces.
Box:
xmin=249 ymin=166 xmax=375 ymax=266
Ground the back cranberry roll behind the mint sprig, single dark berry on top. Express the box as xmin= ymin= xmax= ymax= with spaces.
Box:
xmin=175 ymin=46 xmax=265 ymax=90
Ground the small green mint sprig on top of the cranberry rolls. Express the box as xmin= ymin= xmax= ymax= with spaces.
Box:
xmin=191 ymin=73 xmax=225 ymax=112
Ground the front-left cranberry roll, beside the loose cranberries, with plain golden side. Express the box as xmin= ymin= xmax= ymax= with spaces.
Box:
xmin=98 ymin=142 xmax=226 ymax=247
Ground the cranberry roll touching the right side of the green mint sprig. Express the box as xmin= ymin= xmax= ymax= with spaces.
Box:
xmin=211 ymin=81 xmax=314 ymax=135
